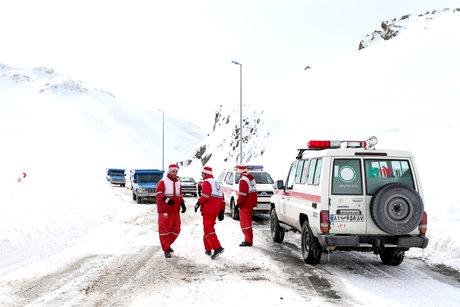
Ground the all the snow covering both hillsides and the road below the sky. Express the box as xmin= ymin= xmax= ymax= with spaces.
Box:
xmin=0 ymin=4 xmax=460 ymax=306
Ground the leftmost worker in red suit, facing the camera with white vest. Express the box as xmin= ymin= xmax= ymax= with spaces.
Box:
xmin=156 ymin=164 xmax=187 ymax=258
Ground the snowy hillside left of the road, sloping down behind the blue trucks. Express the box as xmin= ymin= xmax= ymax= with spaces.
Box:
xmin=0 ymin=65 xmax=204 ymax=269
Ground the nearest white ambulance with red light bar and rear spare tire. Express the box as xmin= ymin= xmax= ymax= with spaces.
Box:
xmin=270 ymin=137 xmax=428 ymax=265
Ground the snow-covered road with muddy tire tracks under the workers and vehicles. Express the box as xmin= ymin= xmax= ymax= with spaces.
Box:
xmin=0 ymin=196 xmax=458 ymax=306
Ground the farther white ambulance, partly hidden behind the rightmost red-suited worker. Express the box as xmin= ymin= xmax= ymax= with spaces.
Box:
xmin=221 ymin=165 xmax=274 ymax=220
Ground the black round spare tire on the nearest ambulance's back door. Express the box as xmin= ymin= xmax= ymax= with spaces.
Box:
xmin=370 ymin=183 xmax=424 ymax=235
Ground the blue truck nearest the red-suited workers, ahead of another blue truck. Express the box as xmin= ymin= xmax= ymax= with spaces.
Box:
xmin=129 ymin=169 xmax=164 ymax=204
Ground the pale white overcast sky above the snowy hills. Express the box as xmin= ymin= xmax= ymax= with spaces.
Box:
xmin=0 ymin=0 xmax=460 ymax=127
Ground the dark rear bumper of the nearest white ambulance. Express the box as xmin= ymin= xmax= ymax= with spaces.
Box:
xmin=318 ymin=234 xmax=428 ymax=249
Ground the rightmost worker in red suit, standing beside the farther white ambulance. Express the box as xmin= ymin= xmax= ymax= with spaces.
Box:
xmin=236 ymin=165 xmax=257 ymax=246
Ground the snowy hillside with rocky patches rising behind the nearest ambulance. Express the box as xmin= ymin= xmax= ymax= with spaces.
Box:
xmin=182 ymin=10 xmax=460 ymax=269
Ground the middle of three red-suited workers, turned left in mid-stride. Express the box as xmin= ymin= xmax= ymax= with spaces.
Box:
xmin=195 ymin=166 xmax=225 ymax=259
